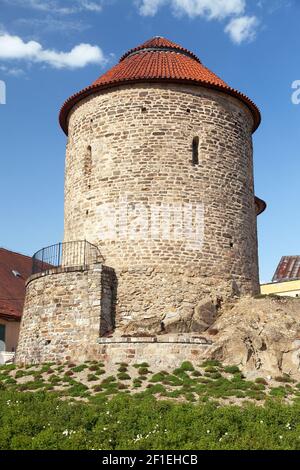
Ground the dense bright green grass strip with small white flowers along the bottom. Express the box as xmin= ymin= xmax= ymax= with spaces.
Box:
xmin=0 ymin=390 xmax=300 ymax=450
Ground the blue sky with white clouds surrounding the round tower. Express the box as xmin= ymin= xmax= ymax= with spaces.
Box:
xmin=0 ymin=0 xmax=300 ymax=281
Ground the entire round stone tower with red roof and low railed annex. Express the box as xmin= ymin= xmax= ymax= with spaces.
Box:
xmin=17 ymin=37 xmax=265 ymax=361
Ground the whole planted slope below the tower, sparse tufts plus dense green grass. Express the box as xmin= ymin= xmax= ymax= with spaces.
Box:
xmin=0 ymin=360 xmax=300 ymax=449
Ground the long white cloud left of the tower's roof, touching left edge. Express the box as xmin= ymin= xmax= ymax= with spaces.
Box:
xmin=0 ymin=33 xmax=106 ymax=69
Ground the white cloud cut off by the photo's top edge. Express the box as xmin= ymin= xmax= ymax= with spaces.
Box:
xmin=138 ymin=0 xmax=246 ymax=19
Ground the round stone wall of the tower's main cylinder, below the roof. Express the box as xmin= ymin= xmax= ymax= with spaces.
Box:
xmin=64 ymin=84 xmax=259 ymax=334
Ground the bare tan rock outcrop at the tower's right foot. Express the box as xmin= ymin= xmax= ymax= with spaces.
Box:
xmin=205 ymin=296 xmax=300 ymax=378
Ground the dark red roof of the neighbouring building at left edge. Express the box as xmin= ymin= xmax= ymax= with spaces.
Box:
xmin=0 ymin=248 xmax=32 ymax=320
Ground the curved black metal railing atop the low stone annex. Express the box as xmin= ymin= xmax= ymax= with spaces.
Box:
xmin=32 ymin=240 xmax=104 ymax=274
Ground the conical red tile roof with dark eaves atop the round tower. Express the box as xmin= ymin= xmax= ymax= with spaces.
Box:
xmin=59 ymin=37 xmax=261 ymax=134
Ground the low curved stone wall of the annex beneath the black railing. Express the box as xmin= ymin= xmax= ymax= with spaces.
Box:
xmin=16 ymin=265 xmax=114 ymax=363
